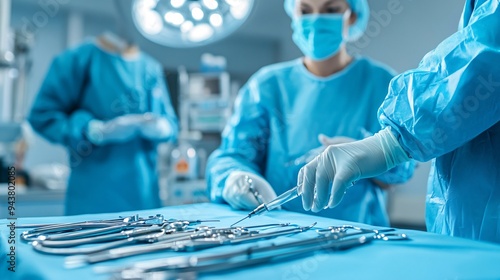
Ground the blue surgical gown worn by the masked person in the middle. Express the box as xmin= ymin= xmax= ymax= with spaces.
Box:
xmin=207 ymin=58 xmax=413 ymax=226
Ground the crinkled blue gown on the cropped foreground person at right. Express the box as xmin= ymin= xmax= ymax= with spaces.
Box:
xmin=379 ymin=0 xmax=500 ymax=243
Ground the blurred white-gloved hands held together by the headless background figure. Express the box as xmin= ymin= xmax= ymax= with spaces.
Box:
xmin=86 ymin=114 xmax=144 ymax=145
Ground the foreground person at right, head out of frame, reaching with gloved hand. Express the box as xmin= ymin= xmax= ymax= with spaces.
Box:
xmin=298 ymin=0 xmax=500 ymax=243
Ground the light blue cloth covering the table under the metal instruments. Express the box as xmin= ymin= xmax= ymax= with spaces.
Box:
xmin=0 ymin=204 xmax=500 ymax=280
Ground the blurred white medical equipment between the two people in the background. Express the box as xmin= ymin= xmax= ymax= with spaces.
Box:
xmin=160 ymin=54 xmax=239 ymax=205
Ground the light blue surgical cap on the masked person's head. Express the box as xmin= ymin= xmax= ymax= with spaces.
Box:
xmin=285 ymin=0 xmax=370 ymax=41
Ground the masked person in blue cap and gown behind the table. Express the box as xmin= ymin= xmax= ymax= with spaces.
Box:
xmin=207 ymin=0 xmax=413 ymax=226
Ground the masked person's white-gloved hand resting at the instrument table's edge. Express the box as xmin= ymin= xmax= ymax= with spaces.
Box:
xmin=222 ymin=171 xmax=276 ymax=210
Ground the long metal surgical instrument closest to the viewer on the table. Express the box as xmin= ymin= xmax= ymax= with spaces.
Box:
xmin=100 ymin=225 xmax=408 ymax=279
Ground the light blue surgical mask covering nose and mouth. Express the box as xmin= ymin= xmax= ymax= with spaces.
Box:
xmin=292 ymin=11 xmax=351 ymax=60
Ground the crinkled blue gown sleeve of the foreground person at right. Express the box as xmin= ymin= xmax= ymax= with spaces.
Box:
xmin=378 ymin=0 xmax=500 ymax=161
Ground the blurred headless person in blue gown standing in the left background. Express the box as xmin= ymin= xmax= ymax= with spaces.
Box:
xmin=29 ymin=33 xmax=178 ymax=215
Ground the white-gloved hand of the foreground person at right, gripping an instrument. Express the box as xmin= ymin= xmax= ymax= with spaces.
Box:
xmin=297 ymin=128 xmax=409 ymax=212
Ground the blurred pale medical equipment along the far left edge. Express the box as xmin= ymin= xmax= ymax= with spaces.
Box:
xmin=0 ymin=0 xmax=34 ymax=186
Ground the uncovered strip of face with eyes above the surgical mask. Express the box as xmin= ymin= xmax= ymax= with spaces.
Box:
xmin=295 ymin=0 xmax=349 ymax=16
